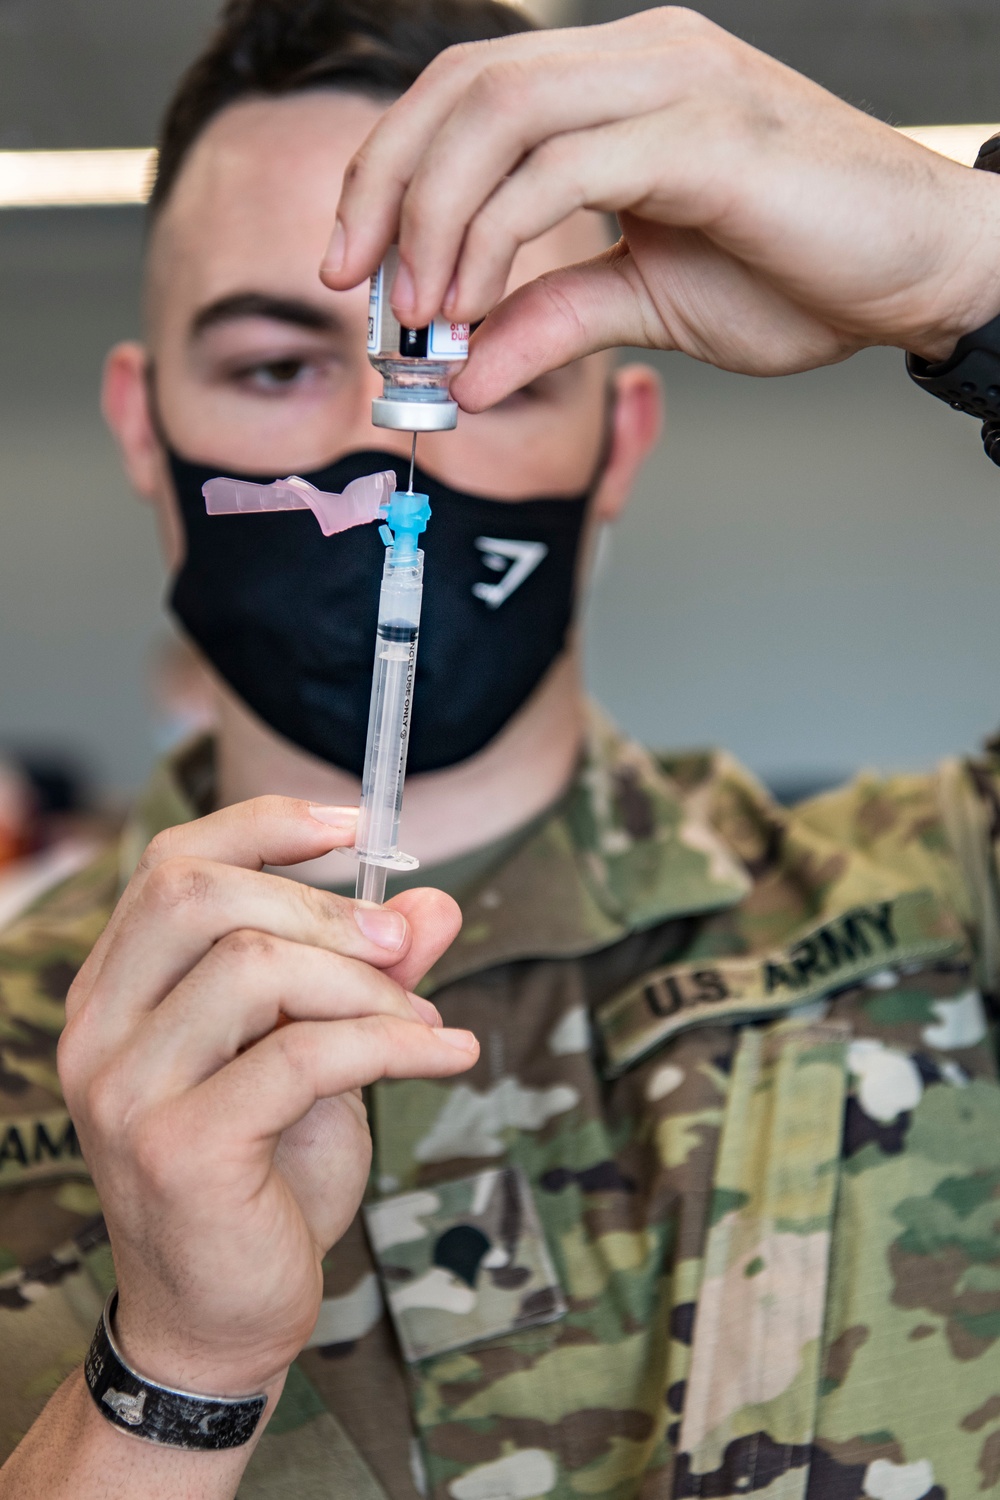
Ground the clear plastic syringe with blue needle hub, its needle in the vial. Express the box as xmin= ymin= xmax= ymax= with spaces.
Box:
xmin=354 ymin=434 xmax=430 ymax=903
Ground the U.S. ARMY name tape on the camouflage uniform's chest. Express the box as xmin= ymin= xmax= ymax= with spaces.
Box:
xmin=595 ymin=891 xmax=966 ymax=1079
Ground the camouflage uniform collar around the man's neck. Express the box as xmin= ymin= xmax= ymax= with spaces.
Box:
xmin=121 ymin=708 xmax=751 ymax=993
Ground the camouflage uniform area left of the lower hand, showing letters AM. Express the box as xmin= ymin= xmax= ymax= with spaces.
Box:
xmin=0 ymin=849 xmax=117 ymax=1463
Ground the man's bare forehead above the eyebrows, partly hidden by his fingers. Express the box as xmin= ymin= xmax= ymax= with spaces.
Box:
xmin=148 ymin=92 xmax=607 ymax=329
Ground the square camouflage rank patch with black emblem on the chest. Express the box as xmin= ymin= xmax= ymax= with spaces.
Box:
xmin=364 ymin=1167 xmax=567 ymax=1364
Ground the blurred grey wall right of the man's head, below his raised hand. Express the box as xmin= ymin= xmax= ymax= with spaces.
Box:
xmin=589 ymin=350 xmax=1000 ymax=788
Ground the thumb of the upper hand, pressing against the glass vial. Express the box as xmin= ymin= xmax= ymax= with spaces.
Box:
xmin=451 ymin=243 xmax=667 ymax=411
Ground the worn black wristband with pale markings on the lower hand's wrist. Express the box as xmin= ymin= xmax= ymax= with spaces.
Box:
xmin=84 ymin=1290 xmax=267 ymax=1452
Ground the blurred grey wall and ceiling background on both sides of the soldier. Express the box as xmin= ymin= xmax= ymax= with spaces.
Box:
xmin=0 ymin=0 xmax=1000 ymax=864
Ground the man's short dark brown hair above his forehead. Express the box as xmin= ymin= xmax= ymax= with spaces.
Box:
xmin=150 ymin=0 xmax=532 ymax=216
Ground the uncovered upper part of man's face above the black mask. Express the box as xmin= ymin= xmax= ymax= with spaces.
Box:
xmin=148 ymin=93 xmax=609 ymax=500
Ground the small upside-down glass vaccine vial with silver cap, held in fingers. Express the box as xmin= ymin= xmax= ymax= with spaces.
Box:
xmin=367 ymin=246 xmax=469 ymax=432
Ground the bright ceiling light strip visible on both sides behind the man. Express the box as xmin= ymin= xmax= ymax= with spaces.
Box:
xmin=0 ymin=125 xmax=1000 ymax=209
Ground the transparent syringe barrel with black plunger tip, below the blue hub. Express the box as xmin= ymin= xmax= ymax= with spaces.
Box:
xmin=355 ymin=542 xmax=424 ymax=858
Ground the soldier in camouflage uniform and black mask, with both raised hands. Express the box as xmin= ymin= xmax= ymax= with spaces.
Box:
xmin=0 ymin=0 xmax=1000 ymax=1500
